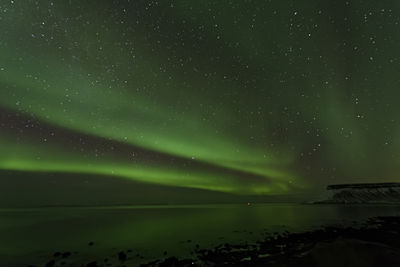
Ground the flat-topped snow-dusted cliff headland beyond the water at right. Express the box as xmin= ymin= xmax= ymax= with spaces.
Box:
xmin=316 ymin=183 xmax=400 ymax=204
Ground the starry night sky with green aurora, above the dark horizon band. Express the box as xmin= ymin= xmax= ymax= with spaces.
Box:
xmin=0 ymin=0 xmax=400 ymax=204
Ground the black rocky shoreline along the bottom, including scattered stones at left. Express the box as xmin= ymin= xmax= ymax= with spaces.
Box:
xmin=23 ymin=216 xmax=400 ymax=267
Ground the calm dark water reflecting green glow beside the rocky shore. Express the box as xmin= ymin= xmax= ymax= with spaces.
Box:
xmin=0 ymin=204 xmax=400 ymax=266
